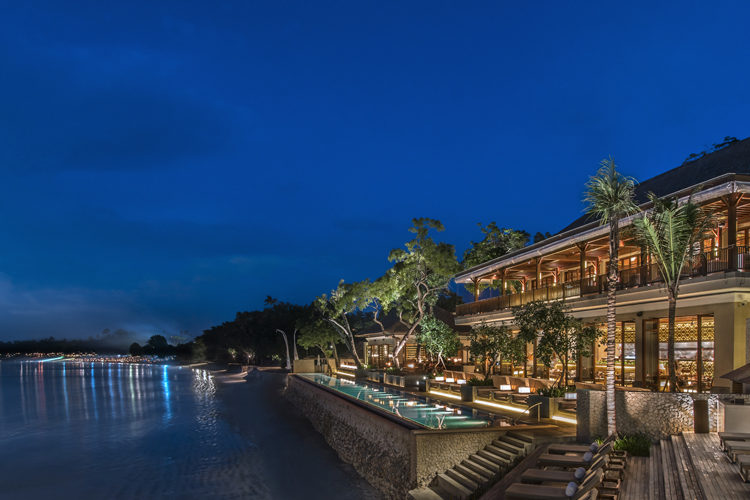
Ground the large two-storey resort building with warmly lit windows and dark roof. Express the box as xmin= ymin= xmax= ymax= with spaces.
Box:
xmin=455 ymin=139 xmax=750 ymax=392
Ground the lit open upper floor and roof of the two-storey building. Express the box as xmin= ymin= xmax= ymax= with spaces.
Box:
xmin=456 ymin=139 xmax=750 ymax=316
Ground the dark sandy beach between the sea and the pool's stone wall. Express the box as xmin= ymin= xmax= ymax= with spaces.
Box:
xmin=214 ymin=371 xmax=380 ymax=500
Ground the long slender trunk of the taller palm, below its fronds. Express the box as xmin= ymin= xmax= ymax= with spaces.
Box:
xmin=606 ymin=218 xmax=620 ymax=436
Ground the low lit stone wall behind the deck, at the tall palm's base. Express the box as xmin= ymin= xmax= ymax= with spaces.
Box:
xmin=576 ymin=389 xmax=750 ymax=441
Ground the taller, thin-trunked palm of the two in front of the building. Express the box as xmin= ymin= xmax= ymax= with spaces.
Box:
xmin=584 ymin=157 xmax=638 ymax=436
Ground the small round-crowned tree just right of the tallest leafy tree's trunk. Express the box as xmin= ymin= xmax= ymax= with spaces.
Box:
xmin=469 ymin=323 xmax=526 ymax=380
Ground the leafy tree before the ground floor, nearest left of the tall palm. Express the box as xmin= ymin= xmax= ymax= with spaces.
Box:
xmin=514 ymin=301 xmax=602 ymax=387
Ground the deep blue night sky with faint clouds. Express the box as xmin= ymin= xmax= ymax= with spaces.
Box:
xmin=0 ymin=0 xmax=750 ymax=339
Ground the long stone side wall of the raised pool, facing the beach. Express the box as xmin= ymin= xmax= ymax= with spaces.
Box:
xmin=285 ymin=377 xmax=417 ymax=498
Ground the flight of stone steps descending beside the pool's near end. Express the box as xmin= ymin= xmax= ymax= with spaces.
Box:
xmin=409 ymin=431 xmax=534 ymax=500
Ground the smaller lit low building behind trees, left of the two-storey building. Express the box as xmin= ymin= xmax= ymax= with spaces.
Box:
xmin=357 ymin=307 xmax=471 ymax=368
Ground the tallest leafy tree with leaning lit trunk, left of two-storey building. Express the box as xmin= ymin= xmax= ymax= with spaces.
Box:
xmin=376 ymin=218 xmax=461 ymax=366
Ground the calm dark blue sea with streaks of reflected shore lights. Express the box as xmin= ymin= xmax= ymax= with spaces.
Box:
xmin=0 ymin=361 xmax=376 ymax=499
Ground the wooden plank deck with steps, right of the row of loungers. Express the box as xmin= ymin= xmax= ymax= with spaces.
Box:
xmin=620 ymin=432 xmax=750 ymax=500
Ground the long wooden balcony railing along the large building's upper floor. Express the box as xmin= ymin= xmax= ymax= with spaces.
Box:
xmin=456 ymin=246 xmax=750 ymax=316
